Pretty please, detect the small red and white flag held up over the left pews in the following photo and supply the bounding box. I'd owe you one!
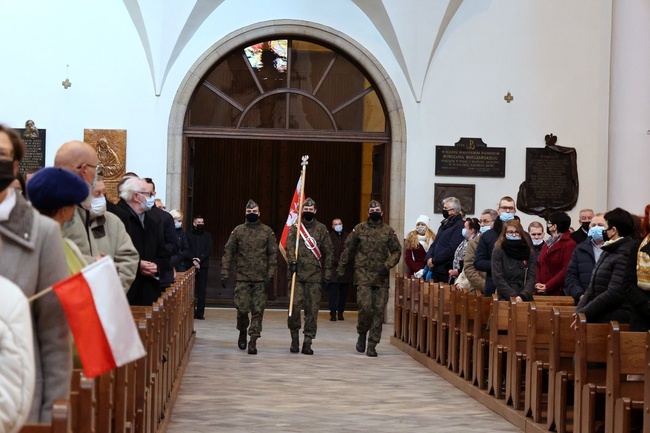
[52,257,146,378]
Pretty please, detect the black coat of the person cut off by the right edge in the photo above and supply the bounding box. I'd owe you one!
[621,241,650,332]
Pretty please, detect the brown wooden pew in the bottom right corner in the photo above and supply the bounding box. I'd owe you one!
[605,322,648,433]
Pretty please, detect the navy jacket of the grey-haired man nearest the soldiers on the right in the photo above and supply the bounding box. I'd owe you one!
[426,215,465,282]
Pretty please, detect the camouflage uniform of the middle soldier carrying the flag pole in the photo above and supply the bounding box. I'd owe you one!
[287,218,334,339]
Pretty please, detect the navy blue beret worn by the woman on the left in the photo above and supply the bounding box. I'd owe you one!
[27,167,90,209]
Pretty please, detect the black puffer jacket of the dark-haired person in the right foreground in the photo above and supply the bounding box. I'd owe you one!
[576,236,634,323]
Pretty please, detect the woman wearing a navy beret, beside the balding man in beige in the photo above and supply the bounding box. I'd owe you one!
[27,167,88,275]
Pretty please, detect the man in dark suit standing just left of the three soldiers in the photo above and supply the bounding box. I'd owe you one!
[185,215,212,320]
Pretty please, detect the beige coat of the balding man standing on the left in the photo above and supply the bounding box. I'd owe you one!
[63,207,140,293]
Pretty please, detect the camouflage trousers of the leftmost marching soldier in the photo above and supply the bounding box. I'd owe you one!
[235,281,266,337]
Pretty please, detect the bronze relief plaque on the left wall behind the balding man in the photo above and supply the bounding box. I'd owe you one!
[84,129,126,203]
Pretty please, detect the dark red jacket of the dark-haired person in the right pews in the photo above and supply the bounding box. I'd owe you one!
[537,231,576,296]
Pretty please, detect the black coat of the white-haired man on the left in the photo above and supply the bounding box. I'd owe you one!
[117,200,171,306]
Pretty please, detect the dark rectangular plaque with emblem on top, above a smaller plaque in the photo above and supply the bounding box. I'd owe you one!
[436,137,506,177]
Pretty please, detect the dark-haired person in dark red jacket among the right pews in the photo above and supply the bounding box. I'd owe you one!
[535,212,576,296]
